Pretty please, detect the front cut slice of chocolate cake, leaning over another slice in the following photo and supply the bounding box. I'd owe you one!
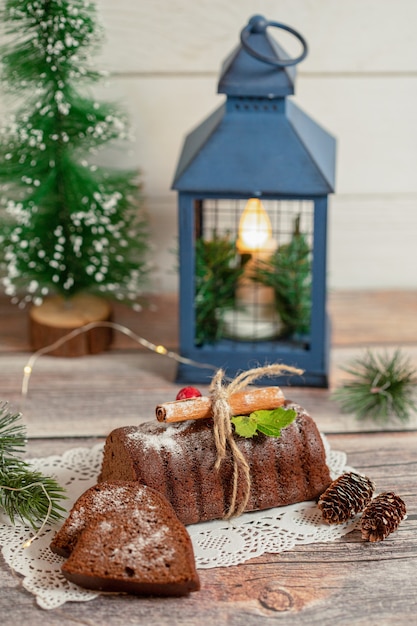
[62,502,200,596]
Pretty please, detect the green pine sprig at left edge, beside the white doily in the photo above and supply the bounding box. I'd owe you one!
[0,403,65,530]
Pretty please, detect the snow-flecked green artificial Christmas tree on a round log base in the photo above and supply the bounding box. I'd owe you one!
[0,0,147,352]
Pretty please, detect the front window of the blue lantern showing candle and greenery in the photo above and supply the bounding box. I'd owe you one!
[194,198,314,350]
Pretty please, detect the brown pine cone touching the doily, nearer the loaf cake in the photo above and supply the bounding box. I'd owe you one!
[318,472,375,524]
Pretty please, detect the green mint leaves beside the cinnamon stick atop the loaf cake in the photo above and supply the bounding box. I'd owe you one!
[231,407,297,437]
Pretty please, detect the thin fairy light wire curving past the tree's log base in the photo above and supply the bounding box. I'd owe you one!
[21,322,217,399]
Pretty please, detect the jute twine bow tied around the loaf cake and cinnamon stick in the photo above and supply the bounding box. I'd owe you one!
[210,364,303,519]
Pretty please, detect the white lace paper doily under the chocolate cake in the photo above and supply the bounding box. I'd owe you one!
[0,439,357,609]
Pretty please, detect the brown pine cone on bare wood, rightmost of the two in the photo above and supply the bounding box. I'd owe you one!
[361,491,407,541]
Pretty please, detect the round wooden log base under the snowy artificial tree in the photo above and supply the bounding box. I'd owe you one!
[29,294,113,357]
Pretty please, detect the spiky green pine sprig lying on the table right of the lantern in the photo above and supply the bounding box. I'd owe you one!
[332,350,417,422]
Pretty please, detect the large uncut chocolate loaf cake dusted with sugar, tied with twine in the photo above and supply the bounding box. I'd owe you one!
[99,401,331,524]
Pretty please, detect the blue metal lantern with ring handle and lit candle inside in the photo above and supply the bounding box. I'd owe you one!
[173,16,336,387]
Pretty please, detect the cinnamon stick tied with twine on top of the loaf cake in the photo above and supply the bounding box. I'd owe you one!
[156,387,285,422]
